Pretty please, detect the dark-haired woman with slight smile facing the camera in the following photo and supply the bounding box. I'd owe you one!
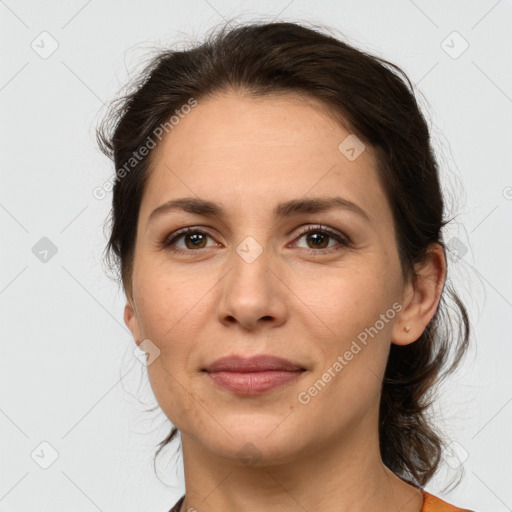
[98,19,476,512]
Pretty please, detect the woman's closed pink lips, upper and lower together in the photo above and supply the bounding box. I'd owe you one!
[204,355,306,396]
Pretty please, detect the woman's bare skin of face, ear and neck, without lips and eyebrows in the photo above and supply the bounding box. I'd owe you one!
[124,92,446,512]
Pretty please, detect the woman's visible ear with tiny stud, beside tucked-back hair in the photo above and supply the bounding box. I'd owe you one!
[391,243,446,345]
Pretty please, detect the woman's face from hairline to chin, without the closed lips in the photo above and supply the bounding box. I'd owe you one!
[125,94,410,462]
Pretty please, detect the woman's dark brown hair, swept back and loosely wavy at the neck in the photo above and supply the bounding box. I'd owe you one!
[97,22,469,486]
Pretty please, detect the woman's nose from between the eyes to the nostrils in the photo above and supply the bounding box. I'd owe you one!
[217,241,290,331]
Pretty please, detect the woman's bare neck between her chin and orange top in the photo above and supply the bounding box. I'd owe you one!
[181,414,423,512]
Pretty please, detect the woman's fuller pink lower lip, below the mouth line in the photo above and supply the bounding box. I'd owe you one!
[207,370,304,395]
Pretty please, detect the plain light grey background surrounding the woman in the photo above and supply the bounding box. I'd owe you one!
[0,0,512,512]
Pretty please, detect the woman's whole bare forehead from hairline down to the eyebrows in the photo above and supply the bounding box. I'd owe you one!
[141,94,387,228]
